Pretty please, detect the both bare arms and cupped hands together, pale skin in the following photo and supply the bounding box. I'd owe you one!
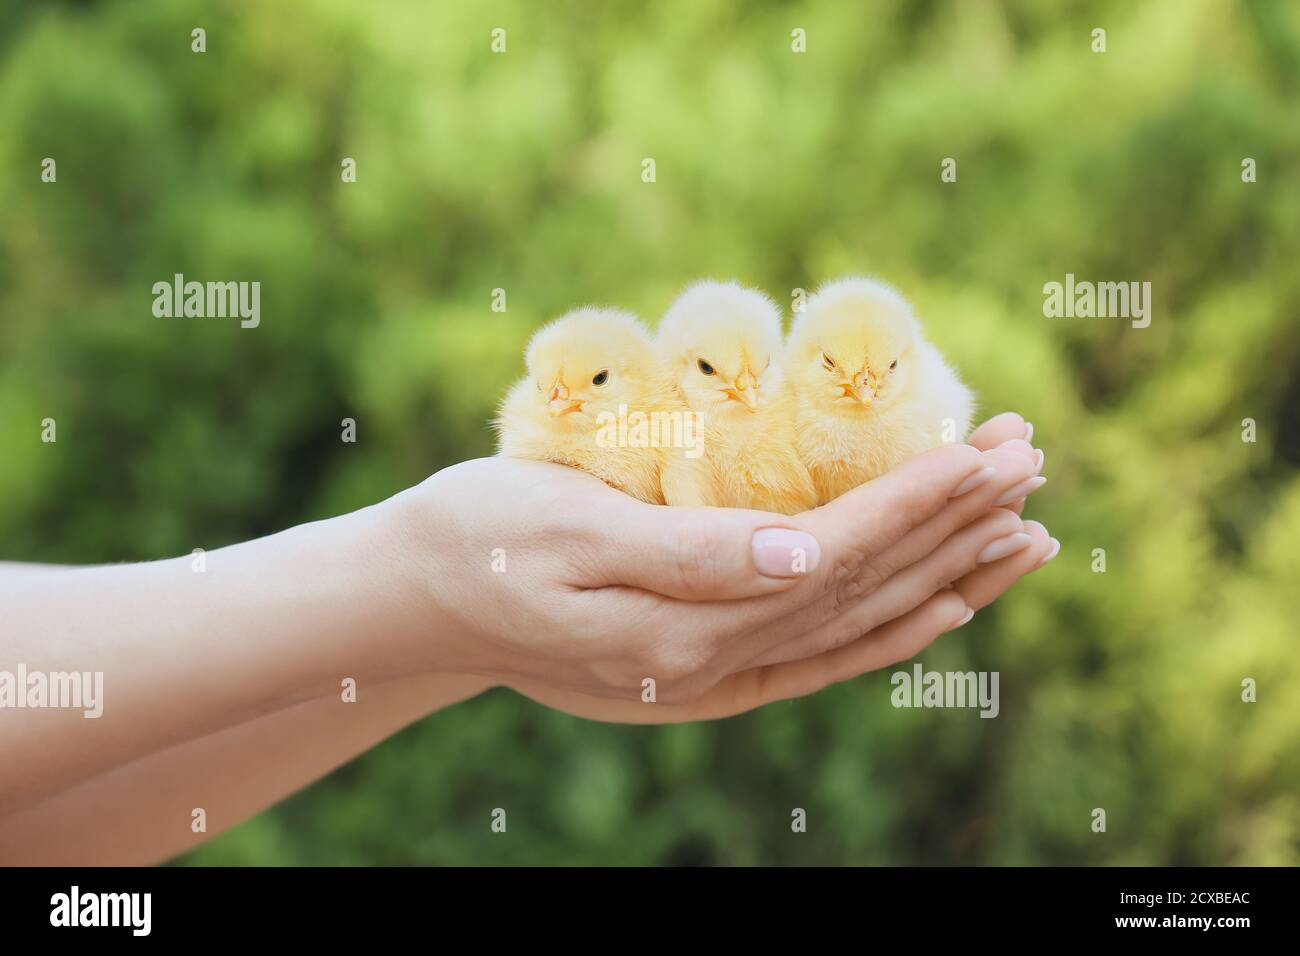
[0,414,1057,864]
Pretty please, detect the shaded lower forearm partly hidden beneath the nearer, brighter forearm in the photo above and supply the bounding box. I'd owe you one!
[0,674,489,866]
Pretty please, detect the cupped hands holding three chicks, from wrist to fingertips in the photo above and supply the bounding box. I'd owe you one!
[399,414,1054,722]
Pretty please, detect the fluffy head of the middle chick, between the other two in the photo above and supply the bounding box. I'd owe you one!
[658,281,781,415]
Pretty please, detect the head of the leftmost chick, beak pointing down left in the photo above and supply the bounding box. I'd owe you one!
[525,306,659,429]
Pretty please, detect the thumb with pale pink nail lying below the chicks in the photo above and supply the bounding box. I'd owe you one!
[593,499,822,601]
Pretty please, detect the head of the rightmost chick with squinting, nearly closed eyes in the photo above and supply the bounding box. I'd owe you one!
[787,278,919,414]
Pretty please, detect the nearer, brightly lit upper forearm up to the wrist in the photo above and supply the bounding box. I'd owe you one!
[0,502,438,813]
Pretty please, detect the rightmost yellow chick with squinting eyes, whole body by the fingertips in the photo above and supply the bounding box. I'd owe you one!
[785,278,974,505]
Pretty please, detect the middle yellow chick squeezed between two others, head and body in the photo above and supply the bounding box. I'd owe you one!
[657,282,816,515]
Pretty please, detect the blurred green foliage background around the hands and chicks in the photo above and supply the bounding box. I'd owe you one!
[0,0,1300,864]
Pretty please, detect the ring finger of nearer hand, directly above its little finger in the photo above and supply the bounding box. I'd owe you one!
[744,509,1034,666]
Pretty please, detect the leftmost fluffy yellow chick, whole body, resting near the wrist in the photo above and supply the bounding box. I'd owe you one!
[493,307,715,505]
